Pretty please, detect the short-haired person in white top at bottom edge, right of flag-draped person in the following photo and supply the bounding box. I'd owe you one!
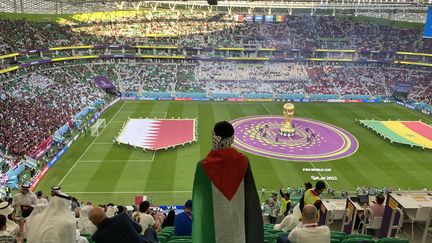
[277,204,330,243]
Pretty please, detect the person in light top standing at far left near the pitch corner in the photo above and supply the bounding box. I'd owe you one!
[12,185,37,217]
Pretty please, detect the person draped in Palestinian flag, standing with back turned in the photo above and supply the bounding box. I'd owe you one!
[192,121,264,243]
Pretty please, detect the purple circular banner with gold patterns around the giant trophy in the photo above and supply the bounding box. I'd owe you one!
[231,116,359,162]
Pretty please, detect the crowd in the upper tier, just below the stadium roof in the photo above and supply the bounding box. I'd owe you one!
[0,11,431,53]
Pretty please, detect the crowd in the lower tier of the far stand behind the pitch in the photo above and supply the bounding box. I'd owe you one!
[2,60,431,104]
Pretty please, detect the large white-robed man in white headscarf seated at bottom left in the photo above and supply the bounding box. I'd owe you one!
[27,192,77,243]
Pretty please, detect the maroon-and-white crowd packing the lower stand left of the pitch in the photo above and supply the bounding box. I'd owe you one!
[0,66,103,159]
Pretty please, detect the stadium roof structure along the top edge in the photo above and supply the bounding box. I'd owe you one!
[0,0,432,22]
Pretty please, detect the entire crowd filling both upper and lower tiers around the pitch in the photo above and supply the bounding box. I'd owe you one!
[0,11,432,173]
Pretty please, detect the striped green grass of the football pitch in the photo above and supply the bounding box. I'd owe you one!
[36,101,432,205]
